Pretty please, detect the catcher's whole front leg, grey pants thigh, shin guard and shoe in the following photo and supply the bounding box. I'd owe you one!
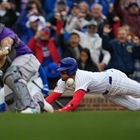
[4,54,40,112]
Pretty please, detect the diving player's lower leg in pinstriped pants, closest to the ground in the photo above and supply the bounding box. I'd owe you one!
[105,95,140,111]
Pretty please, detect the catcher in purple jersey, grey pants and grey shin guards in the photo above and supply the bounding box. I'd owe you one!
[0,23,44,113]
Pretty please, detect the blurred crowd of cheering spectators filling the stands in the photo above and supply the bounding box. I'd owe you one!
[0,0,140,89]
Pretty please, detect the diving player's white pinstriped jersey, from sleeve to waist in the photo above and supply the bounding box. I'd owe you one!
[54,69,114,94]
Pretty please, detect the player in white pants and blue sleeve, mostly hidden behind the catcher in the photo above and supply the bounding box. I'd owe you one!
[0,65,53,113]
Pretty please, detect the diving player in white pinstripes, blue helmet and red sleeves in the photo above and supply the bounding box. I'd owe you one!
[45,57,140,112]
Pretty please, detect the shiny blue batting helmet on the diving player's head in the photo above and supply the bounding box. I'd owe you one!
[57,57,78,76]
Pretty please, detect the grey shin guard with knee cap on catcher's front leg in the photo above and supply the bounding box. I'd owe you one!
[3,66,34,111]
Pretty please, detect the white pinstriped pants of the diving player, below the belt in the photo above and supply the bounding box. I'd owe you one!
[104,70,140,110]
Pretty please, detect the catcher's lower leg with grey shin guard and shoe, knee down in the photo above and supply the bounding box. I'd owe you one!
[4,66,40,113]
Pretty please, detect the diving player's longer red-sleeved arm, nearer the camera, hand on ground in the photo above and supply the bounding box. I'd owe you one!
[58,90,86,112]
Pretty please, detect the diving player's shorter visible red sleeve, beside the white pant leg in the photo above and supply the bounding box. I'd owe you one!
[45,92,62,104]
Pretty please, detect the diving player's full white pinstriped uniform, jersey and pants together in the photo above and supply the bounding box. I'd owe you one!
[54,69,140,110]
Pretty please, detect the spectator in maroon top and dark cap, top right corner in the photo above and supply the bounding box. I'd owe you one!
[114,0,140,38]
